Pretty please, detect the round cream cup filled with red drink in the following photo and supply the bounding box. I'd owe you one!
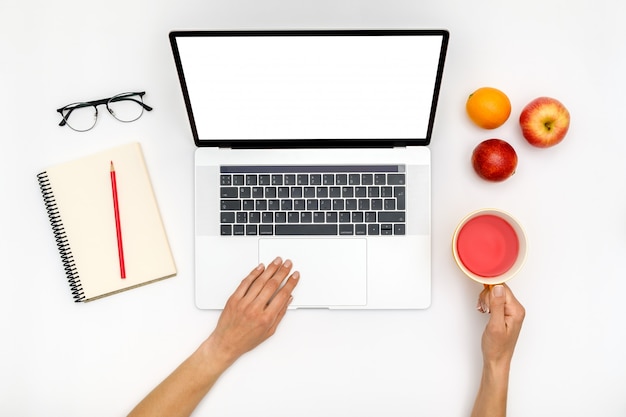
[452,208,526,285]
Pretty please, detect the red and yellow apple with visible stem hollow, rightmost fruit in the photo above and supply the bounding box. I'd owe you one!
[519,97,570,148]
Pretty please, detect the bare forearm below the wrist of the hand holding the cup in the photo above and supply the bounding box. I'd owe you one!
[472,364,509,417]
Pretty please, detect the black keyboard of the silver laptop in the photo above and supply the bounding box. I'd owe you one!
[220,165,406,236]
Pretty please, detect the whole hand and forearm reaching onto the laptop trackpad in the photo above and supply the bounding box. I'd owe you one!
[129,257,300,417]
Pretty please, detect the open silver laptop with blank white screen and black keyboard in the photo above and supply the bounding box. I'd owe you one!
[169,30,449,310]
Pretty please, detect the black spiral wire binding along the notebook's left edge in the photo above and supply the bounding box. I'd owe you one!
[37,171,85,303]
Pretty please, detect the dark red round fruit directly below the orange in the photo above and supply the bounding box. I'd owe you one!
[472,139,517,181]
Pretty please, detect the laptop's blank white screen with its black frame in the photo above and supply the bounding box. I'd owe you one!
[169,30,449,148]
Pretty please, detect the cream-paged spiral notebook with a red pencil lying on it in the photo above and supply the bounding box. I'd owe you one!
[37,143,176,302]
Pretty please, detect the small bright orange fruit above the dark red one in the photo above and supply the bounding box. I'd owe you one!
[465,87,511,129]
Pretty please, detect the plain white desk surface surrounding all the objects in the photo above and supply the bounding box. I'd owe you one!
[0,0,626,417]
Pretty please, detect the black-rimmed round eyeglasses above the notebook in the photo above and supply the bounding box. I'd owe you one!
[57,91,152,132]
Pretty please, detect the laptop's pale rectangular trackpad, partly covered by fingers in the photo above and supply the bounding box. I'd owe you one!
[259,238,367,307]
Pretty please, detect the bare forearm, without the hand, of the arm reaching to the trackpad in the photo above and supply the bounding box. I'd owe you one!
[129,341,232,417]
